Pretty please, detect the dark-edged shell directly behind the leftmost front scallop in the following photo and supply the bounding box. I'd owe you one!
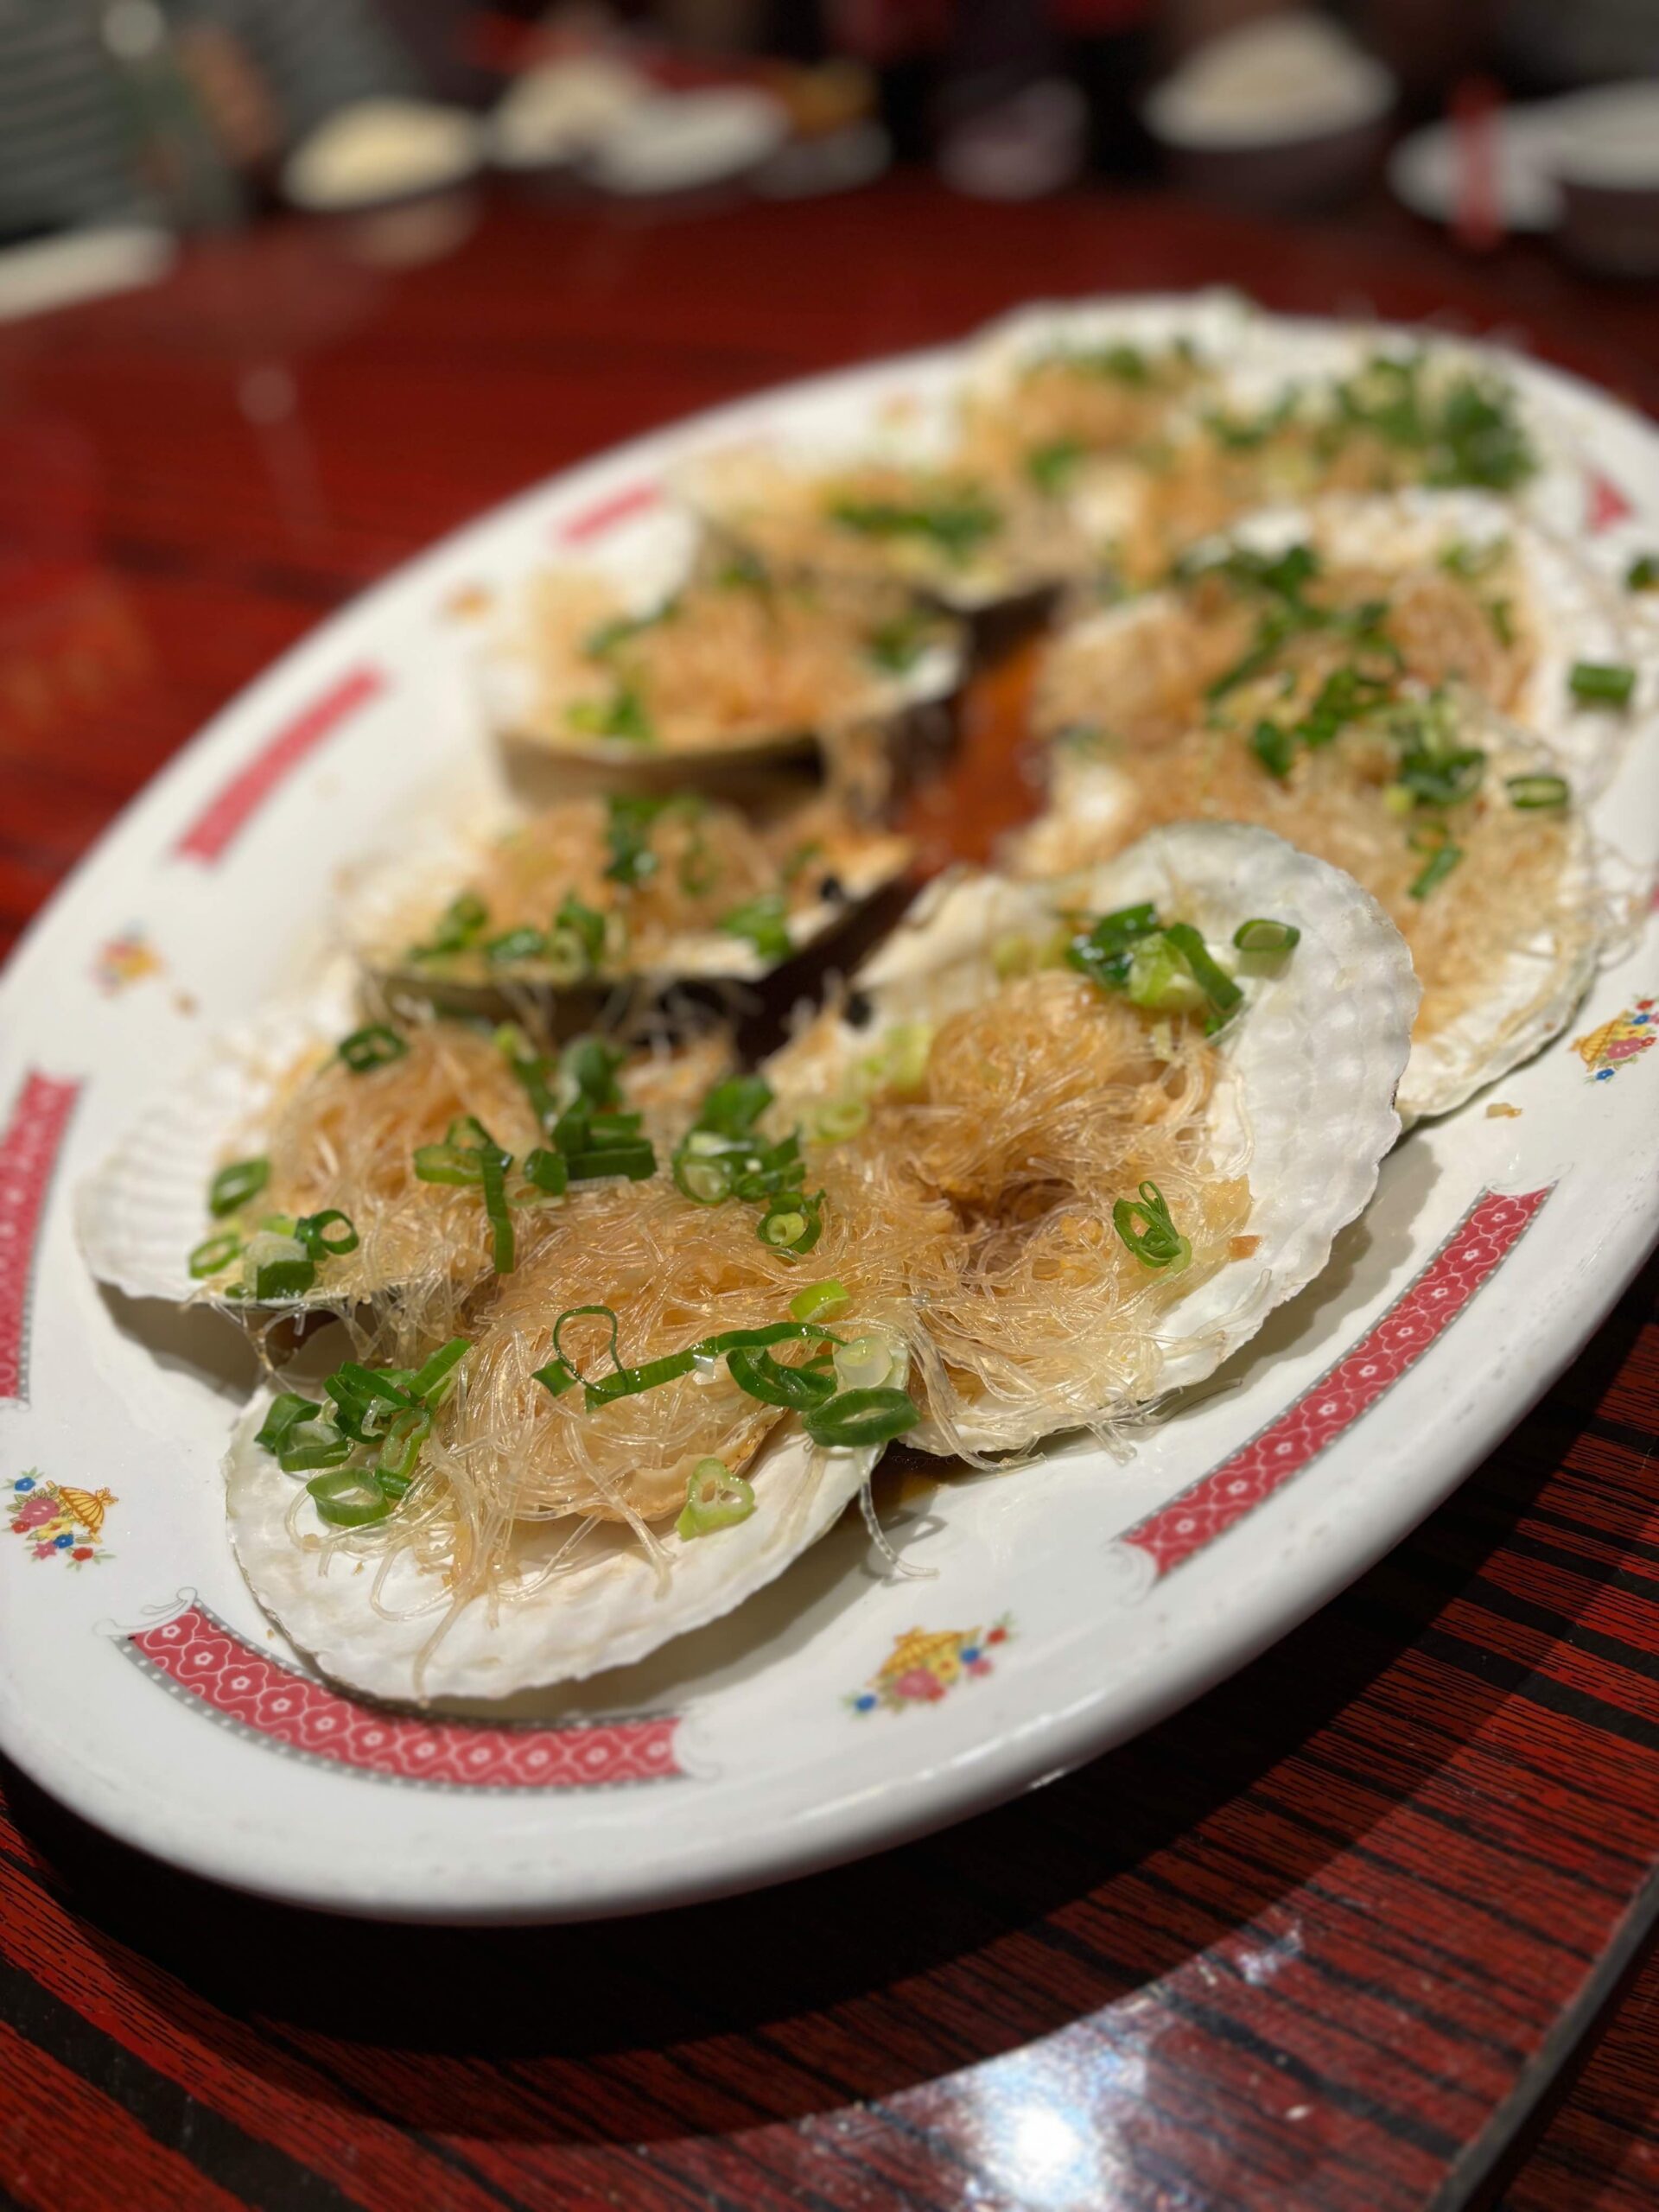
[343,817,913,1004]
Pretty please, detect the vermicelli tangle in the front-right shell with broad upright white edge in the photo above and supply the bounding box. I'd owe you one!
[798,971,1249,1445]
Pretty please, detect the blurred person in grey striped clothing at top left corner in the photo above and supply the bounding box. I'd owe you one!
[0,0,416,238]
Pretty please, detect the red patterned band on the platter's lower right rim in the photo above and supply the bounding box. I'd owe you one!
[1119,1184,1555,1575]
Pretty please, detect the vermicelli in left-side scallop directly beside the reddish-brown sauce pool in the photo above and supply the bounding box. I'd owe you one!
[524,557,947,752]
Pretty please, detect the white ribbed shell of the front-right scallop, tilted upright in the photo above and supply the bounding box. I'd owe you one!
[767,823,1418,1453]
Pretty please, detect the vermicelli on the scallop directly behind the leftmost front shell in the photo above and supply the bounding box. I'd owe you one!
[389,791,909,982]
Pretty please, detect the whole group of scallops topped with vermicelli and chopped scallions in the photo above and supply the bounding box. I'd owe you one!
[78,296,1659,1701]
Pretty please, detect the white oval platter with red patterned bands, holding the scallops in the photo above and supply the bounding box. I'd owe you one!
[0,301,1659,1920]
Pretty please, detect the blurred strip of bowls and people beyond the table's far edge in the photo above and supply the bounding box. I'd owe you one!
[0,0,1659,249]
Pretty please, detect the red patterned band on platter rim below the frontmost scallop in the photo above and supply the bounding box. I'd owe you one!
[122,1599,686,1789]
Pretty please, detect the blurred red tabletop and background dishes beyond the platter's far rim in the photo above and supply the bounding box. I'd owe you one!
[0,0,1659,951]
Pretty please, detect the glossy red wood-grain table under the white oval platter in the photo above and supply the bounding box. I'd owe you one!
[0,179,1659,2212]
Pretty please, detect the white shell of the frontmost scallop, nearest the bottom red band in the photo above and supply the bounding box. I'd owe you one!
[226,1391,880,1701]
